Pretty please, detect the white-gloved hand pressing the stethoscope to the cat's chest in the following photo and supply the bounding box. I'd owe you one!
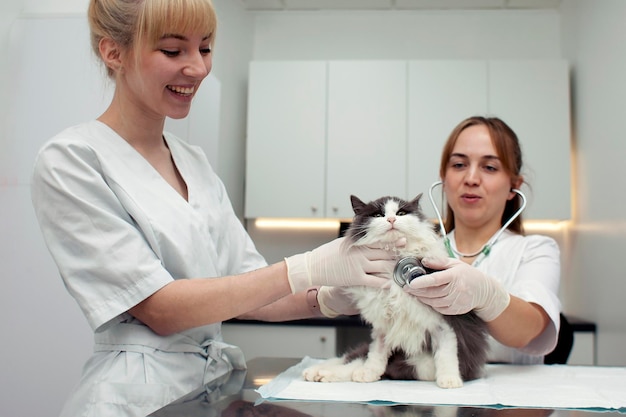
[404,258,511,321]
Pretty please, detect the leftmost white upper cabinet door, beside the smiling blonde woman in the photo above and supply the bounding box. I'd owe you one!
[245,61,326,218]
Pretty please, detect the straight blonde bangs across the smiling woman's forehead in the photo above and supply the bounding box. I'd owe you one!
[137,0,217,45]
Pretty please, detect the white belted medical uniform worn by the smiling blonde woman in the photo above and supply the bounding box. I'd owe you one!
[32,121,266,417]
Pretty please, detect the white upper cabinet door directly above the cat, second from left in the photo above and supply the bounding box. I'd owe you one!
[326,61,407,218]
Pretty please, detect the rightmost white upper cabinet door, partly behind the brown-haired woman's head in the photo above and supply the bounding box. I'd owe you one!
[489,60,571,220]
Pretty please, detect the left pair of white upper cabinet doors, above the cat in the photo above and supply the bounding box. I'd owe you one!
[245,61,406,218]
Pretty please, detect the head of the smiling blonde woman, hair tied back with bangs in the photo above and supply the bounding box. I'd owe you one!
[88,0,217,123]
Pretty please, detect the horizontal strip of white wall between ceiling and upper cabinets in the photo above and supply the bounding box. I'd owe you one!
[254,10,560,60]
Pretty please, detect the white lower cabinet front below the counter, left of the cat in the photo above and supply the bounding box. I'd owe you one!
[222,323,337,360]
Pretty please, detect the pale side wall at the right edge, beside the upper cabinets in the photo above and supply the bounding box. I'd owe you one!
[562,0,626,365]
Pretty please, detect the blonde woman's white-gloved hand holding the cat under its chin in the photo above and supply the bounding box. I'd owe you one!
[285,238,399,294]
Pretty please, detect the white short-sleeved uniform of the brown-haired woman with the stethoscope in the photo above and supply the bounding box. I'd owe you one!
[448,230,561,364]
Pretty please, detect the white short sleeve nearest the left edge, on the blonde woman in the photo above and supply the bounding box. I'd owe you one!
[31,136,172,330]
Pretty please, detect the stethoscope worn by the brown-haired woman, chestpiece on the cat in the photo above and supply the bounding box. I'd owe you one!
[393,180,526,287]
